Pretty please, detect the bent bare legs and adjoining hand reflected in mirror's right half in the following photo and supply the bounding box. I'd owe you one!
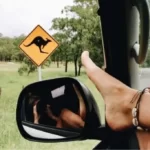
[43,84,86,128]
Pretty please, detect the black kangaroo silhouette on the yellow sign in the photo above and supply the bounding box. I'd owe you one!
[24,36,51,54]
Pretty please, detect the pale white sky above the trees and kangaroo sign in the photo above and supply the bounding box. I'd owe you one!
[0,0,73,37]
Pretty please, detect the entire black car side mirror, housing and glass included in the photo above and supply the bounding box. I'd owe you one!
[16,77,106,142]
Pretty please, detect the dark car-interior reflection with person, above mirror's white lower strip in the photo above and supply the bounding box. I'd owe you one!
[25,84,86,129]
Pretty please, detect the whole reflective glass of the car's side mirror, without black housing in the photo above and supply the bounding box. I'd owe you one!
[21,81,86,139]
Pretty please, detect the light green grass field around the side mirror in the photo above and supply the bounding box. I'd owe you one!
[0,63,104,150]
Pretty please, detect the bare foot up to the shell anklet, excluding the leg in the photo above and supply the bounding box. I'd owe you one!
[81,51,137,131]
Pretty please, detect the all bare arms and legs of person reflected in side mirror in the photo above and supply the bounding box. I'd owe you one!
[33,85,86,128]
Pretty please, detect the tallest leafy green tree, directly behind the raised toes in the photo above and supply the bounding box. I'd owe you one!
[51,0,103,76]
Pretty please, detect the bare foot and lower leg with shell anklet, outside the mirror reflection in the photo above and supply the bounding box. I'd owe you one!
[81,51,150,150]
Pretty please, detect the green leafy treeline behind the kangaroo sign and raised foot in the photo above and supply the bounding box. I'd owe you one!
[0,0,150,76]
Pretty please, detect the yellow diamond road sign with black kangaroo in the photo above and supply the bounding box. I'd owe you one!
[19,25,58,66]
